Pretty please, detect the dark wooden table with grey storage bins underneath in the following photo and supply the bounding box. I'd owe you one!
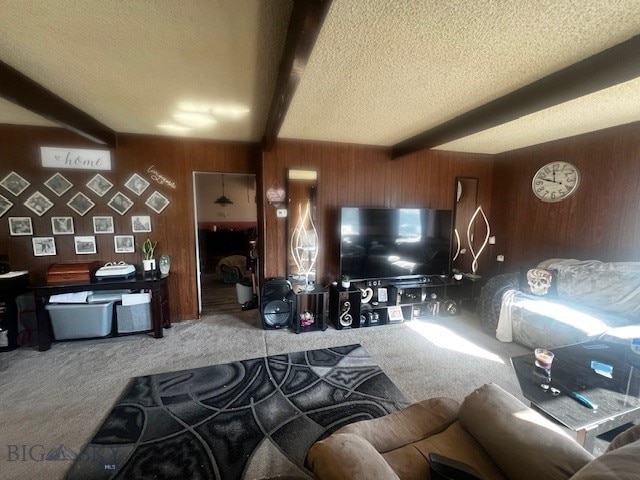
[32,274,171,352]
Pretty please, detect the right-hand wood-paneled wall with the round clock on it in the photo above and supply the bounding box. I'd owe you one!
[492,123,640,271]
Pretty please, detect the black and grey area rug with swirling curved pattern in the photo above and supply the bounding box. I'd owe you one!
[67,344,409,479]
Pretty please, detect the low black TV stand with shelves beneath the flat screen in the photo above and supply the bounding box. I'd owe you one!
[329,275,462,330]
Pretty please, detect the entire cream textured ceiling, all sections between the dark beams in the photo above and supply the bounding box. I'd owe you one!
[0,0,640,153]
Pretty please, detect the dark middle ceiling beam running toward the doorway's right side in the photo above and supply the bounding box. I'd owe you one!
[262,0,331,151]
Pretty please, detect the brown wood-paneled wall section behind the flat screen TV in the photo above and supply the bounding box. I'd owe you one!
[262,140,493,284]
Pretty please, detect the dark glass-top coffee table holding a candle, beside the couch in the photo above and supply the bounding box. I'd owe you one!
[511,341,640,452]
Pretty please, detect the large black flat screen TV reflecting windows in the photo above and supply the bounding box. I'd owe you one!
[340,207,453,280]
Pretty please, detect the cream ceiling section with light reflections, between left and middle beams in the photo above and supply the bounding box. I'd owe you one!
[0,0,291,140]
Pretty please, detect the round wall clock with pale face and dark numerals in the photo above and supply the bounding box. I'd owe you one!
[531,161,580,202]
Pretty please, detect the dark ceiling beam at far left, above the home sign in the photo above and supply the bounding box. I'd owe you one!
[0,61,116,147]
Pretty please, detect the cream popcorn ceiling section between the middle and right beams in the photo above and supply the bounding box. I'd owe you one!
[280,0,640,151]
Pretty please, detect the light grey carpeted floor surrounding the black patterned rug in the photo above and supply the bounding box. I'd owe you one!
[0,310,528,479]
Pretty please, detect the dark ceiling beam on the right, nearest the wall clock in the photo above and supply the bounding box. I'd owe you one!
[392,35,640,159]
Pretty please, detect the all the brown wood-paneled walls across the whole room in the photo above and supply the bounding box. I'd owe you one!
[16,118,640,321]
